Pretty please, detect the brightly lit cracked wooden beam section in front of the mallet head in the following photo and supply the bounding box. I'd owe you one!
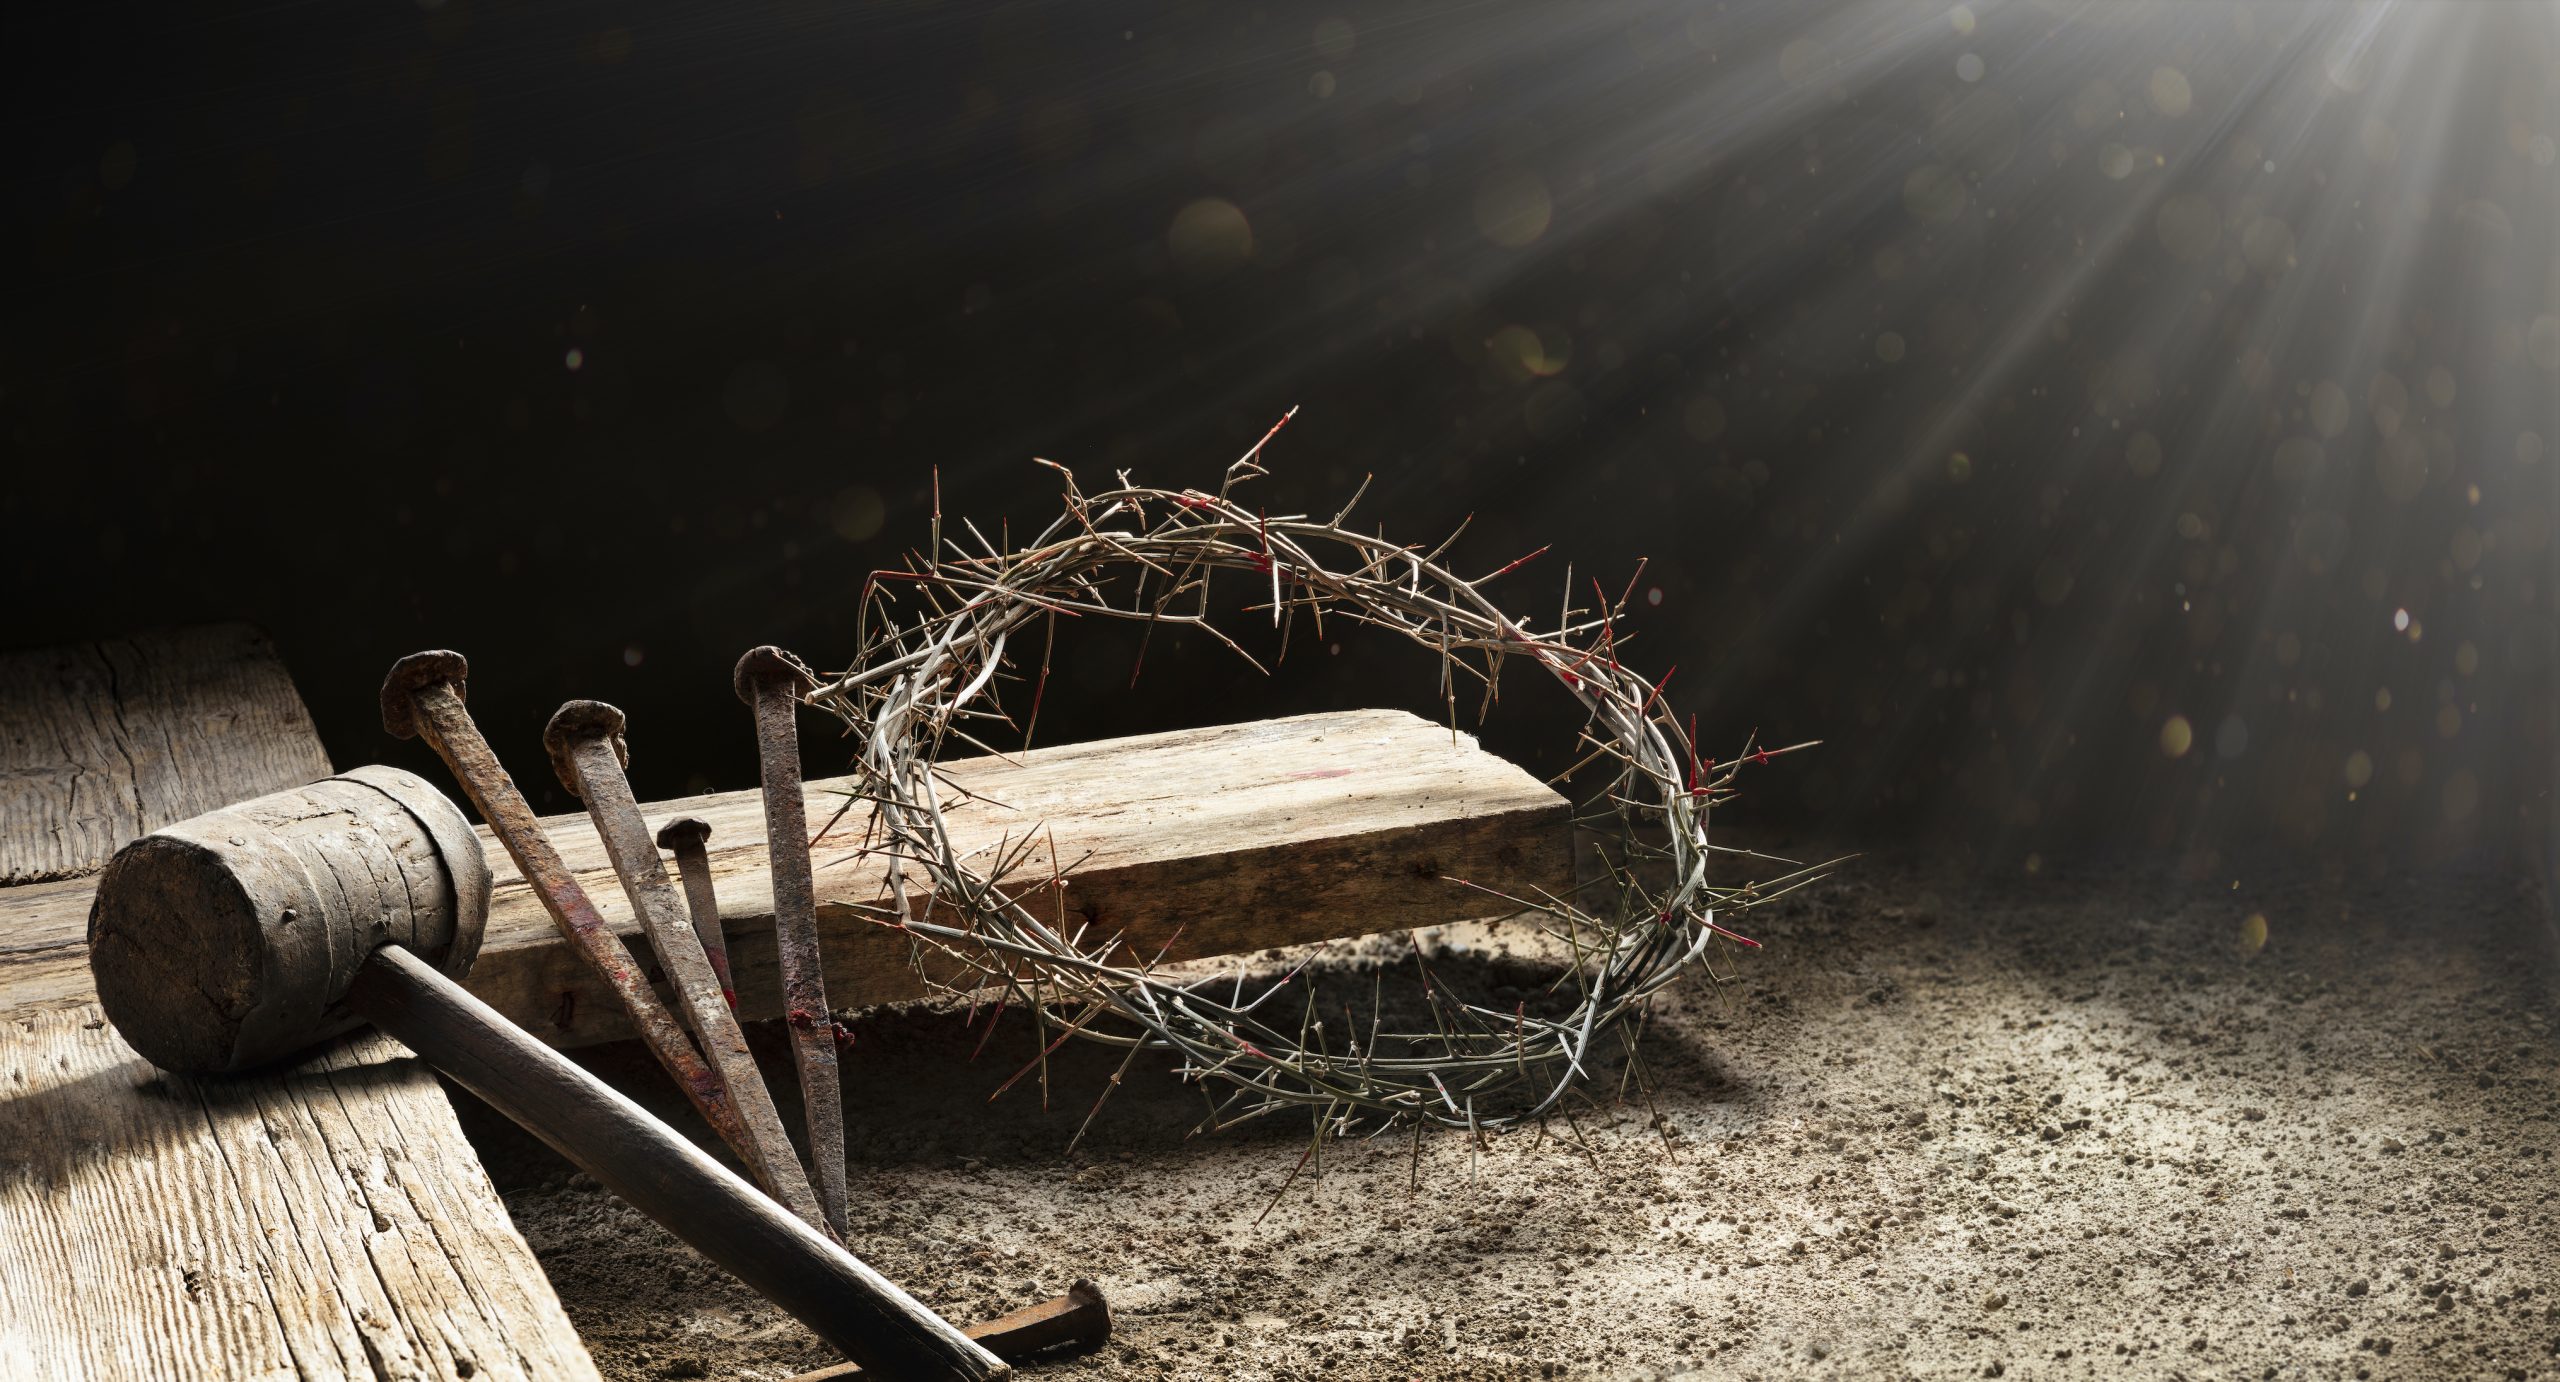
[0,1008,596,1382]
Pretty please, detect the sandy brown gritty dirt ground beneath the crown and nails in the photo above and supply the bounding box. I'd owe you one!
[463,860,2560,1379]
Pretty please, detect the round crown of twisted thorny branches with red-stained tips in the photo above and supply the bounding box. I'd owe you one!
[806,435,1815,1139]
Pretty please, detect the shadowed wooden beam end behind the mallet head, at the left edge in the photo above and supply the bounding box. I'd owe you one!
[0,624,330,886]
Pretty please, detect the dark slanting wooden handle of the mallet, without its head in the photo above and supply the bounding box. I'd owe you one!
[346,944,1009,1379]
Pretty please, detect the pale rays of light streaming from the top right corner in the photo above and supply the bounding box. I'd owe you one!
[1034,3,2552,873]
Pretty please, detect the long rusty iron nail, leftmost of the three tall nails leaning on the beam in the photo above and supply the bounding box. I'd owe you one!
[381,650,745,1187]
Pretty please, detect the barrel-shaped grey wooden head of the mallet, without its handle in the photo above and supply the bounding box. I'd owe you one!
[90,768,489,1072]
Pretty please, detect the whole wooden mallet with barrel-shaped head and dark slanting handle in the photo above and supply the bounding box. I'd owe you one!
[90,768,1006,1379]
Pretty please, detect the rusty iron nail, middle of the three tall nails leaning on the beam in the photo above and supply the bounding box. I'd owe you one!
[543,701,827,1234]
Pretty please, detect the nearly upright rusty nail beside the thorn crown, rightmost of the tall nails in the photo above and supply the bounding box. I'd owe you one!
[735,645,845,1231]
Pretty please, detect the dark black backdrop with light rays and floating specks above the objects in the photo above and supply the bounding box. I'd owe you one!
[20,0,2560,875]
